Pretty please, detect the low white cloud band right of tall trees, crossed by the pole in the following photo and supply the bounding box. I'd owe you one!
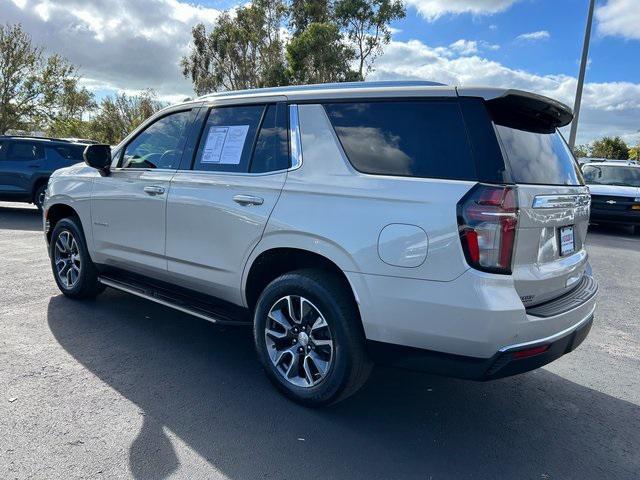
[371,40,640,144]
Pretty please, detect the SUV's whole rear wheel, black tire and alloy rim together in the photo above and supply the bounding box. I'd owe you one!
[254,270,371,407]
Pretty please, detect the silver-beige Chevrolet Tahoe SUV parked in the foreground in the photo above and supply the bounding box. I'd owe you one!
[44,82,597,405]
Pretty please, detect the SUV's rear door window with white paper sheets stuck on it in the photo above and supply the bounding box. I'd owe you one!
[194,105,265,173]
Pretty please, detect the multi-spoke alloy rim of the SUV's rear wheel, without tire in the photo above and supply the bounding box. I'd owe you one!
[264,295,334,388]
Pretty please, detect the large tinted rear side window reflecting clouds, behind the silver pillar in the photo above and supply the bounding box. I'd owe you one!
[325,100,477,180]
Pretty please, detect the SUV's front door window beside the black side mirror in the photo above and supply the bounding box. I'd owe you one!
[121,110,191,169]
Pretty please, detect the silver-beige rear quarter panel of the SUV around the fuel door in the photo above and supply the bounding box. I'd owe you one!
[254,105,473,282]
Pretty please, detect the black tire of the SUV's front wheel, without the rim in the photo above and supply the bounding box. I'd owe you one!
[49,217,104,299]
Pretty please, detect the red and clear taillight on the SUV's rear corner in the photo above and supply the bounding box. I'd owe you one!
[458,184,518,274]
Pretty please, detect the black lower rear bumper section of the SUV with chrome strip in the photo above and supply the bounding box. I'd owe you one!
[368,313,593,381]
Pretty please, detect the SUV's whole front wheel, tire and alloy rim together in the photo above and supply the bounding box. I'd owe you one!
[49,217,104,298]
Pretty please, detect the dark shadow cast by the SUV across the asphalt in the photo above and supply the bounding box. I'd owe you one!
[48,290,640,480]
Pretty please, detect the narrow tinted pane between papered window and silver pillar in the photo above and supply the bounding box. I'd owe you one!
[250,105,289,173]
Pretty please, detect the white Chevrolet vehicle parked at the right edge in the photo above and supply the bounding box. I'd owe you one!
[582,160,640,233]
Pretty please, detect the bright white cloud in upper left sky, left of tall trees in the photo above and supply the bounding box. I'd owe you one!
[0,0,220,99]
